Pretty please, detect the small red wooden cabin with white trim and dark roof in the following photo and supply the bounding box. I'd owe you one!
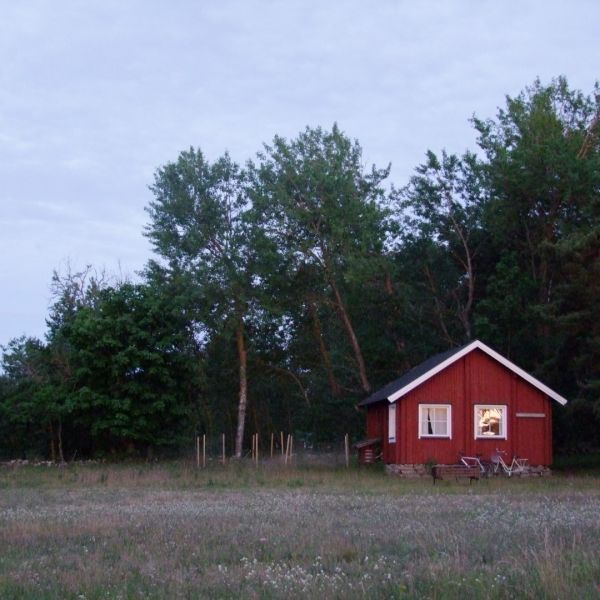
[359,340,567,466]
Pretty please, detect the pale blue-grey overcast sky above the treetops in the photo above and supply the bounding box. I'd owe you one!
[0,0,600,344]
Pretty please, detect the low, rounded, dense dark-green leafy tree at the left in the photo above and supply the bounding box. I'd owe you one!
[64,283,199,452]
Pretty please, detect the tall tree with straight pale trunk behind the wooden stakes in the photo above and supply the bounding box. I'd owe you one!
[146,148,253,457]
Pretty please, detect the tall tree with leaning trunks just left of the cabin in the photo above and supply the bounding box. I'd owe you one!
[250,125,389,393]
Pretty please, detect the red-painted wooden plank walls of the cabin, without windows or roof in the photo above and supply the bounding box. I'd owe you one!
[367,350,552,465]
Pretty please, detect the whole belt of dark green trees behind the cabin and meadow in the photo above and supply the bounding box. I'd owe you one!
[0,78,600,460]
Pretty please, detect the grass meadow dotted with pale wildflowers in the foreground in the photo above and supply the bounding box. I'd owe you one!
[0,462,600,599]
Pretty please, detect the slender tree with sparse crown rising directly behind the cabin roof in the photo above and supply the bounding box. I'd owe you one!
[397,151,486,344]
